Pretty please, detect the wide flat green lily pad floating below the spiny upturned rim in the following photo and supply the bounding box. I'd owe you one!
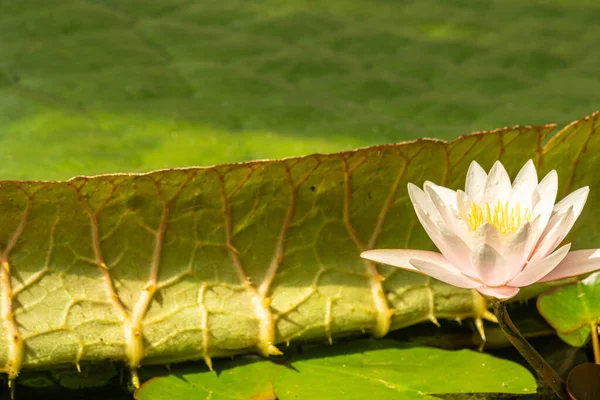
[136,340,536,400]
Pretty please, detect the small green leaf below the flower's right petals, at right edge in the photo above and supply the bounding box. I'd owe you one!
[537,273,600,346]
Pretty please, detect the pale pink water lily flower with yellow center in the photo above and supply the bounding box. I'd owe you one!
[361,160,600,300]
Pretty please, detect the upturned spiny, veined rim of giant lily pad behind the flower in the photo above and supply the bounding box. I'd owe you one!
[0,113,600,388]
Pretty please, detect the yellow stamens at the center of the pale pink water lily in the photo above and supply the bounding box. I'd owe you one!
[467,200,531,235]
